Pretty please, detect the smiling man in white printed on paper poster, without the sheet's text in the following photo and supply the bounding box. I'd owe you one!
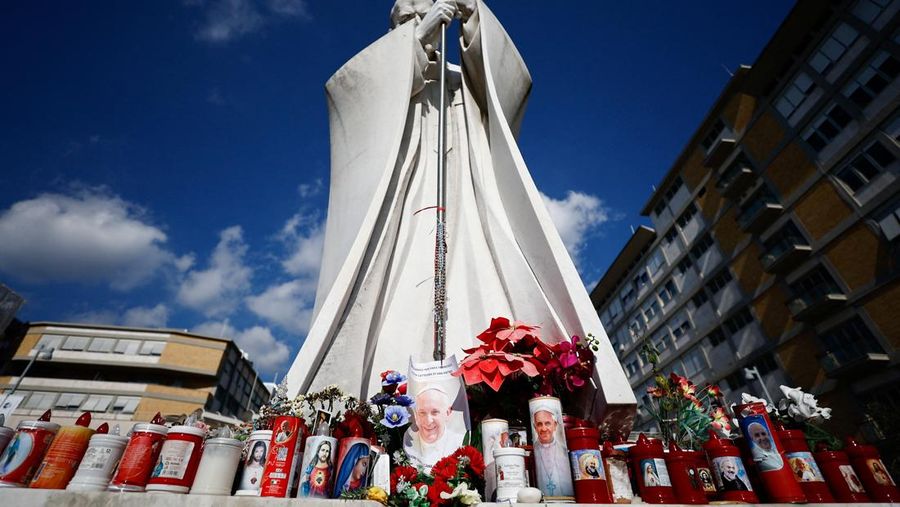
[403,385,465,467]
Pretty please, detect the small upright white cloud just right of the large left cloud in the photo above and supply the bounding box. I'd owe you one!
[177,226,253,317]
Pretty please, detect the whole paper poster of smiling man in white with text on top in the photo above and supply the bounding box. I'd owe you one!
[403,357,469,467]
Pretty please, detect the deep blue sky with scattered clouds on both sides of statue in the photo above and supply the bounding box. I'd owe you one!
[0,0,792,377]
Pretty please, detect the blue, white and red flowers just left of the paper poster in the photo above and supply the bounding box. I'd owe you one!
[369,370,413,455]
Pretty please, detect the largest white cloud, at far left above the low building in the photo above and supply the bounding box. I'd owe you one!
[0,188,176,290]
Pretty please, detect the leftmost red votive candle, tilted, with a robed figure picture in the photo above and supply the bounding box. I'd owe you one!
[0,410,59,488]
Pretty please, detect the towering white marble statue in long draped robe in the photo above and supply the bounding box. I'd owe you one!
[288,0,635,428]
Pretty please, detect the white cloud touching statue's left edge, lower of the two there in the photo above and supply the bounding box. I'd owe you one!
[246,280,316,335]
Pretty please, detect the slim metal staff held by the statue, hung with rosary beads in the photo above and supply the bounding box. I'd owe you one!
[434,24,447,361]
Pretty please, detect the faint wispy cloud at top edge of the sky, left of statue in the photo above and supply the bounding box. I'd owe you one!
[186,0,309,43]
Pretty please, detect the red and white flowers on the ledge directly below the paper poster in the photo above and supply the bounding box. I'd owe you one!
[388,446,484,507]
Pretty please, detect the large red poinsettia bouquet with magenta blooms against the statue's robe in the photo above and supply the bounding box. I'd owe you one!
[453,317,598,423]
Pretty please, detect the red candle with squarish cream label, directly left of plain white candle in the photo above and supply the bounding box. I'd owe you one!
[146,426,206,494]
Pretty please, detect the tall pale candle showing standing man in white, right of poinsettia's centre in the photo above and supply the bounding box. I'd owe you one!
[528,397,575,498]
